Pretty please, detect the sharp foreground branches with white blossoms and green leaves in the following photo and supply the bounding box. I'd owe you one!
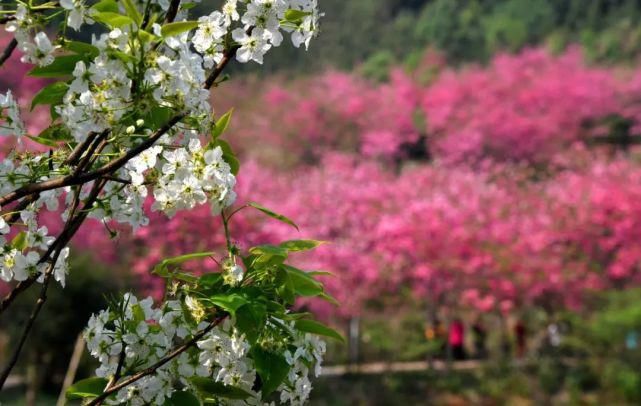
[0,0,337,404]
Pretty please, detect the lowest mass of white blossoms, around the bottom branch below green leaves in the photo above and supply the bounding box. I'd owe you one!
[84,294,325,405]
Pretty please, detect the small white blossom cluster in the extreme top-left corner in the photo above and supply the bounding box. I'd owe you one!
[6,3,56,66]
